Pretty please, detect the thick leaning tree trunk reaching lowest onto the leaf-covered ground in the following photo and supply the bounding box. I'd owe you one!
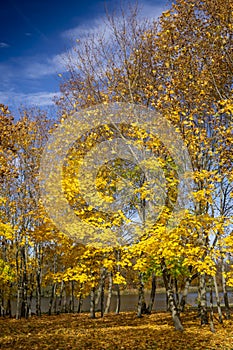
[161,259,184,331]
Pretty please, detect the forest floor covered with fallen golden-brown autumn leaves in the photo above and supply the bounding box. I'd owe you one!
[0,311,233,350]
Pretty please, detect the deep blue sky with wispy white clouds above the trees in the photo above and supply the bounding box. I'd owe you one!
[0,0,167,113]
